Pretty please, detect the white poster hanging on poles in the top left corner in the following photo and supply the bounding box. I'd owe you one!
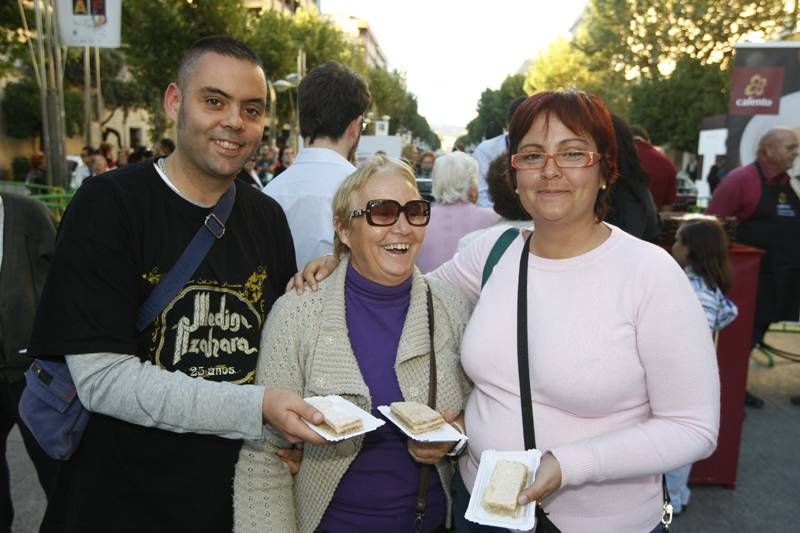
[56,0,122,48]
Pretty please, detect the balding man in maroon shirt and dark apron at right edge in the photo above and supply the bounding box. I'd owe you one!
[707,128,800,408]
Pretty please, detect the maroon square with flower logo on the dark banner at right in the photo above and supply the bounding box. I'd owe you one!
[728,67,783,115]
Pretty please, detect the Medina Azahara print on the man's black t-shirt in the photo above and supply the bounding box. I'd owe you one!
[148,267,267,383]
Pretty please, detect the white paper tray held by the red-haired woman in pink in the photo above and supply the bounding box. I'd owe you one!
[464,450,542,531]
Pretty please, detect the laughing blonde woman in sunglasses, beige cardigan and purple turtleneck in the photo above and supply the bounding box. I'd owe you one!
[234,156,470,533]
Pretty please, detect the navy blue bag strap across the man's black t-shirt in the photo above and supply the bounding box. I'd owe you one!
[136,182,236,331]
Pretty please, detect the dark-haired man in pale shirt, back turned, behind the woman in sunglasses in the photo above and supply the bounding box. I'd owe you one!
[264,61,370,268]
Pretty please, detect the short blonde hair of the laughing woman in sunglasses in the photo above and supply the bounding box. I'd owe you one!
[333,155,418,259]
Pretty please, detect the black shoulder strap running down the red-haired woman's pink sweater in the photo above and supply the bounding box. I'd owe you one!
[517,233,672,533]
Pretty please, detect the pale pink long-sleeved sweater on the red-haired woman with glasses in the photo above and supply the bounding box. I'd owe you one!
[433,226,719,533]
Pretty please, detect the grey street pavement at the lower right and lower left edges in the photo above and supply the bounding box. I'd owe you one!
[8,326,800,533]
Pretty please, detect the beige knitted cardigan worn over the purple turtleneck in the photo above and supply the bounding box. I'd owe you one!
[234,260,471,533]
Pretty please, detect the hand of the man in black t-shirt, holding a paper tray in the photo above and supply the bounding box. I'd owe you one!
[261,389,326,445]
